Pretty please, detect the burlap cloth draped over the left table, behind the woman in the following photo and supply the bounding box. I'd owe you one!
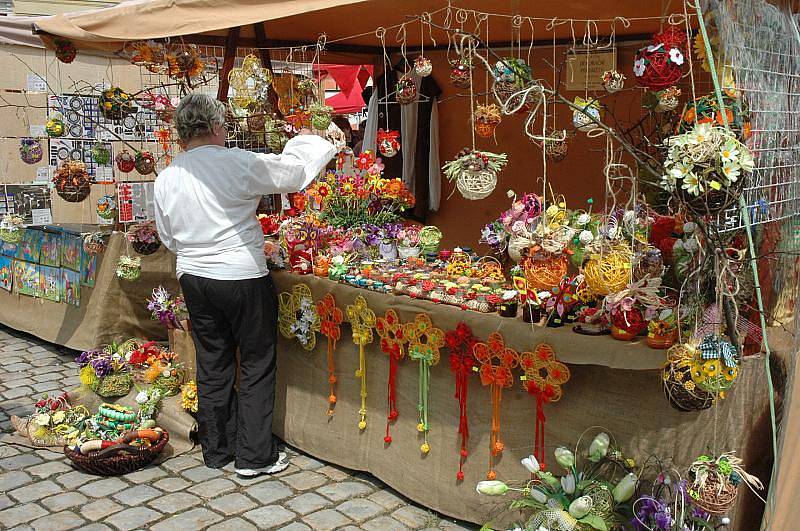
[0,232,178,350]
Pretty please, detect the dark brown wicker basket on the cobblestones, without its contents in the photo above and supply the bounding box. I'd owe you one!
[64,431,169,476]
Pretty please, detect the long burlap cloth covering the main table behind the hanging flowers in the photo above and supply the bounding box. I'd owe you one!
[174,272,770,530]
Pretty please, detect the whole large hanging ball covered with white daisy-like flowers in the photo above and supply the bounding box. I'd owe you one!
[661,124,755,216]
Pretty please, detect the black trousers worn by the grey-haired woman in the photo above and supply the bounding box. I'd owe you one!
[180,274,278,468]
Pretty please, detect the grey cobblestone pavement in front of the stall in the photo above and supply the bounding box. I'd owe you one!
[0,325,474,531]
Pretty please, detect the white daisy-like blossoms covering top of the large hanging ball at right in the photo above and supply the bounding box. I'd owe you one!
[661,124,755,197]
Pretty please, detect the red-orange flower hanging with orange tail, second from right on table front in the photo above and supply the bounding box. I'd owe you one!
[472,332,519,480]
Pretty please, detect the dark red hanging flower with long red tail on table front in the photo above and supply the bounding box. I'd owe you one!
[444,322,477,481]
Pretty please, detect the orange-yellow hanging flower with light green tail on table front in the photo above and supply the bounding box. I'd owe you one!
[403,313,444,454]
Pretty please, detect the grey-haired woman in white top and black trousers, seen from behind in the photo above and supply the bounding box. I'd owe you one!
[155,94,335,477]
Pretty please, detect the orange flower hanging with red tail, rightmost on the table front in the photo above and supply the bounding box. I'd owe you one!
[520,343,570,468]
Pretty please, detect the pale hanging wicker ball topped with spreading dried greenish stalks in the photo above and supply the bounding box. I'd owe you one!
[442,148,508,201]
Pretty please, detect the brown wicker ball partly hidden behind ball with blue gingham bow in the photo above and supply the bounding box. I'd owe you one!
[661,344,714,411]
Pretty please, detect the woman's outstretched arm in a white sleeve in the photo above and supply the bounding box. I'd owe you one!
[249,135,336,195]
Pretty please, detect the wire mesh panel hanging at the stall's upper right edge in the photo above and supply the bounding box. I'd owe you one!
[710,0,800,231]
